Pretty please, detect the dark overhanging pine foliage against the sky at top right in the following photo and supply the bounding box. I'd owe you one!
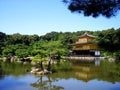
[63,0,120,17]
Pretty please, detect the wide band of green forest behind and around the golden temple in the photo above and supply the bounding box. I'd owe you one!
[0,28,120,58]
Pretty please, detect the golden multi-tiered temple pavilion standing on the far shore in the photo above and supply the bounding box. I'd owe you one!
[71,33,100,56]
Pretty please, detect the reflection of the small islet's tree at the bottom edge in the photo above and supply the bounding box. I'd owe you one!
[30,76,64,90]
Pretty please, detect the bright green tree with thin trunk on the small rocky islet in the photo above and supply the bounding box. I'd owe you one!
[30,40,68,70]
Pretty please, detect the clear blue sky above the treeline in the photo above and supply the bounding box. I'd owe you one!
[0,0,120,36]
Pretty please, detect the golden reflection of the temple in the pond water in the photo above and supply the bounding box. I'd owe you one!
[74,65,100,82]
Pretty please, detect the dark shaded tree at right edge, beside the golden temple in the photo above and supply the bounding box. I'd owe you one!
[97,28,120,56]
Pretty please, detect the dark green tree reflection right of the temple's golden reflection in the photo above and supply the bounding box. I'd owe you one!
[97,61,120,83]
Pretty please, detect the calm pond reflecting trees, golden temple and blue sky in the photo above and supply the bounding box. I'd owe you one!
[0,61,120,90]
